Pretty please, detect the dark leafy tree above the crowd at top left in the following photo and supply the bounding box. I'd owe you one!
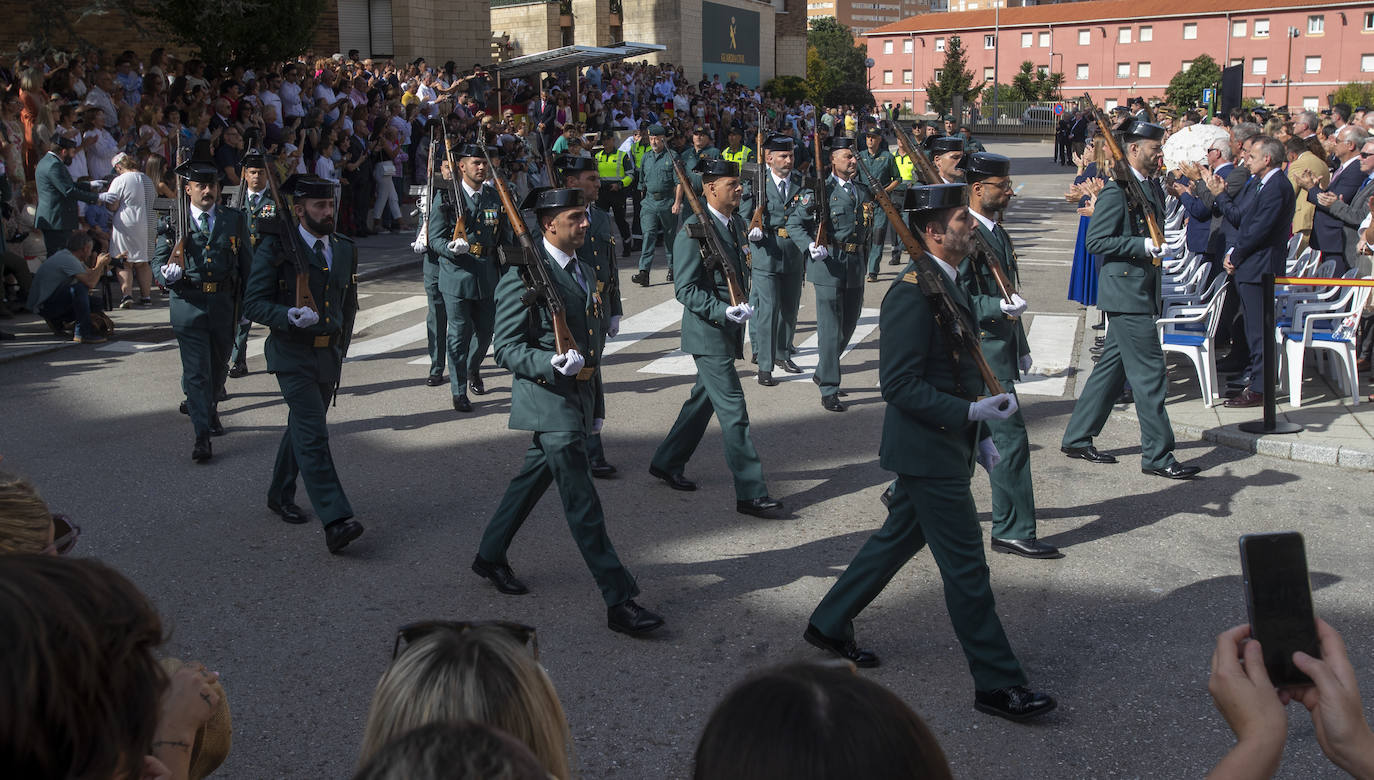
[143,0,324,69]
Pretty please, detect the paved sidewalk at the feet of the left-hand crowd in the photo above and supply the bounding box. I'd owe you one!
[0,231,420,364]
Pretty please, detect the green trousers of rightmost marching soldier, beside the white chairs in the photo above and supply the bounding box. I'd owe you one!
[1063,314,1175,468]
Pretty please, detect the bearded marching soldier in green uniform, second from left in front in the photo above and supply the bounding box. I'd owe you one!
[243,176,363,553]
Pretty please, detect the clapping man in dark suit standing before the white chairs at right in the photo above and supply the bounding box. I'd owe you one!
[1208,136,1301,408]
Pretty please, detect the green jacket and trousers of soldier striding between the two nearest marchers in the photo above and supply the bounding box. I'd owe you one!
[650,209,768,501]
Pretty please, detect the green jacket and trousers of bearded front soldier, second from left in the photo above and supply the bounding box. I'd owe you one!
[243,220,357,526]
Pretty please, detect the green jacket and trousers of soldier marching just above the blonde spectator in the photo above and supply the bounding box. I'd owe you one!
[478,240,639,606]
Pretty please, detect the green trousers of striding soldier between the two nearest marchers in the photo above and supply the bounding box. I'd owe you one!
[650,354,768,501]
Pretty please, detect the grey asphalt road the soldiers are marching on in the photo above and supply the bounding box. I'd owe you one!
[0,144,1374,779]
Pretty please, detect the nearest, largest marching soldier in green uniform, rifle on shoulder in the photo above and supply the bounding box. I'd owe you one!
[802,184,1055,721]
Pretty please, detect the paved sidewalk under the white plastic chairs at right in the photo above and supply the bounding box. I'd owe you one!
[1074,309,1374,471]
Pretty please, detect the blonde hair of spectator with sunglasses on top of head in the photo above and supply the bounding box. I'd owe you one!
[359,628,570,780]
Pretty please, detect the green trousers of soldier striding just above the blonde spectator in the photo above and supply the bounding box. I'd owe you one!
[477,431,639,607]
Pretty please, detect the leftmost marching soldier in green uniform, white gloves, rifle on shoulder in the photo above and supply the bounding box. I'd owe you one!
[153,162,253,463]
